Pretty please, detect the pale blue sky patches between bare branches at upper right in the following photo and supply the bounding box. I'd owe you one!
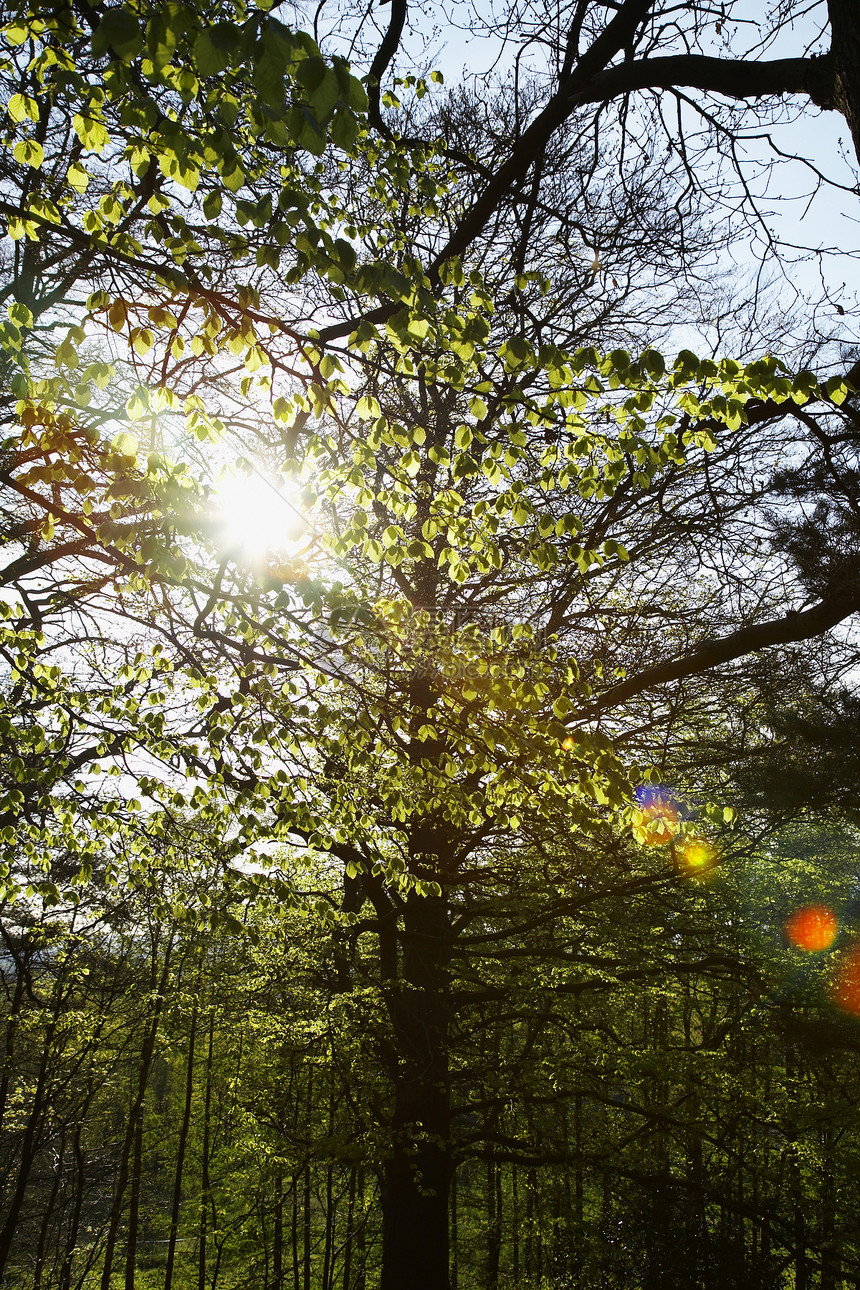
[306,0,860,365]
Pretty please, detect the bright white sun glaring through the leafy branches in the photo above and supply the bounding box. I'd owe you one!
[213,471,311,565]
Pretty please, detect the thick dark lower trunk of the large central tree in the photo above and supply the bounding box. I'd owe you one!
[380,891,454,1290]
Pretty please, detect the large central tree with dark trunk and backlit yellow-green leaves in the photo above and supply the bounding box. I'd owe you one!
[1,0,857,1290]
